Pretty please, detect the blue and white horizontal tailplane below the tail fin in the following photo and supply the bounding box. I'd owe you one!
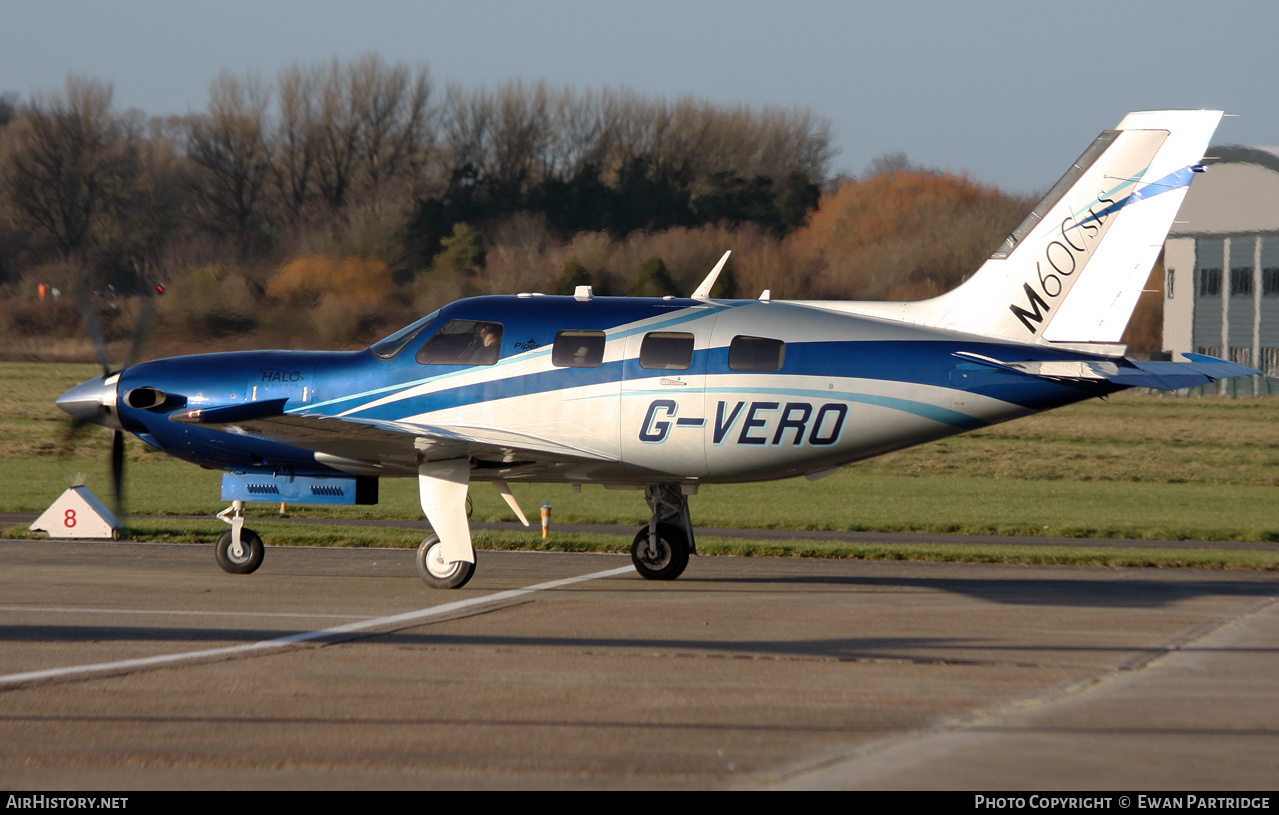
[954,351,1261,390]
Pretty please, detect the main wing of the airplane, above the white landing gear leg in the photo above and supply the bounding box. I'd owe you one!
[171,399,614,473]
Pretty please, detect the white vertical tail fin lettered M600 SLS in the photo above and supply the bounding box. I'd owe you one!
[828,110,1221,343]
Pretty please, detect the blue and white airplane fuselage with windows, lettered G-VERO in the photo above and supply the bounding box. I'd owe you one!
[116,296,1118,484]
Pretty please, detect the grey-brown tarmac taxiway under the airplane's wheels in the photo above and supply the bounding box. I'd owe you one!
[0,540,1279,791]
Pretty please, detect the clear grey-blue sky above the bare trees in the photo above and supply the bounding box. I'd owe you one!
[0,0,1279,194]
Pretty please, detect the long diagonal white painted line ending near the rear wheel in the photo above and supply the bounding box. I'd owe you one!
[0,564,634,687]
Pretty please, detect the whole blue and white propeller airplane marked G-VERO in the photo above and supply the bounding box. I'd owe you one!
[58,110,1257,587]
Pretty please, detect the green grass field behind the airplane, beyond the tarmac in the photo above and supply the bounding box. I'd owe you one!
[9,363,1279,562]
